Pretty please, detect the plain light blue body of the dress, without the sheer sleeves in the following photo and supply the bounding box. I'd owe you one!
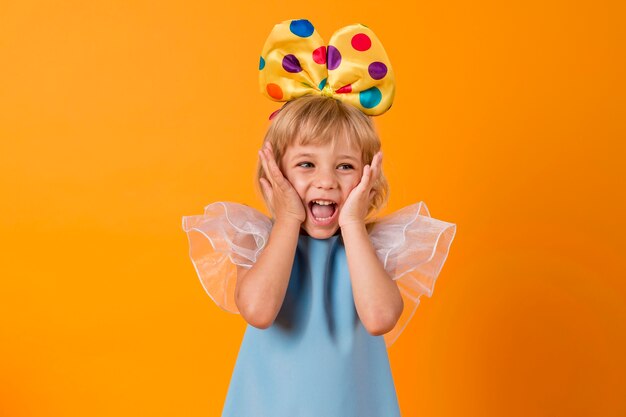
[222,235,400,417]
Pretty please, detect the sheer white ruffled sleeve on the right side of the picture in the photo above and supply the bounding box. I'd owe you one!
[370,201,456,347]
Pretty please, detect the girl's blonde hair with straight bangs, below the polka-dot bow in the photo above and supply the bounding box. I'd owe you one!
[255,95,389,222]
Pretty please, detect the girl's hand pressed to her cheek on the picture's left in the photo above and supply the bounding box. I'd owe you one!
[259,142,306,224]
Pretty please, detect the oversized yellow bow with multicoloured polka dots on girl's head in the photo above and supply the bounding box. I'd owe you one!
[259,19,395,118]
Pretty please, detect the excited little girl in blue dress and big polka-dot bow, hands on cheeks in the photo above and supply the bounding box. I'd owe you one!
[183,19,456,417]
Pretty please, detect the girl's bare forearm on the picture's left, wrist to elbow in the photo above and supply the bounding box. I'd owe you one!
[235,220,300,328]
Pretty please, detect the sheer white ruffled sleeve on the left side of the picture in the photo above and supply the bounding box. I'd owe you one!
[178,202,272,313]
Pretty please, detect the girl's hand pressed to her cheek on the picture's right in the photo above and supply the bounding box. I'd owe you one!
[339,151,383,227]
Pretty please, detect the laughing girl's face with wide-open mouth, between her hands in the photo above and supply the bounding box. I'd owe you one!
[280,140,364,239]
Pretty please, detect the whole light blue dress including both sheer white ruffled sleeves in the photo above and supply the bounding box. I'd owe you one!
[183,202,456,417]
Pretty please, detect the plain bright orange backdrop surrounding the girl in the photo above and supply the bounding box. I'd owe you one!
[0,0,626,417]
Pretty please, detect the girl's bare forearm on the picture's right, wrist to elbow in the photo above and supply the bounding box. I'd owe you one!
[341,223,404,335]
